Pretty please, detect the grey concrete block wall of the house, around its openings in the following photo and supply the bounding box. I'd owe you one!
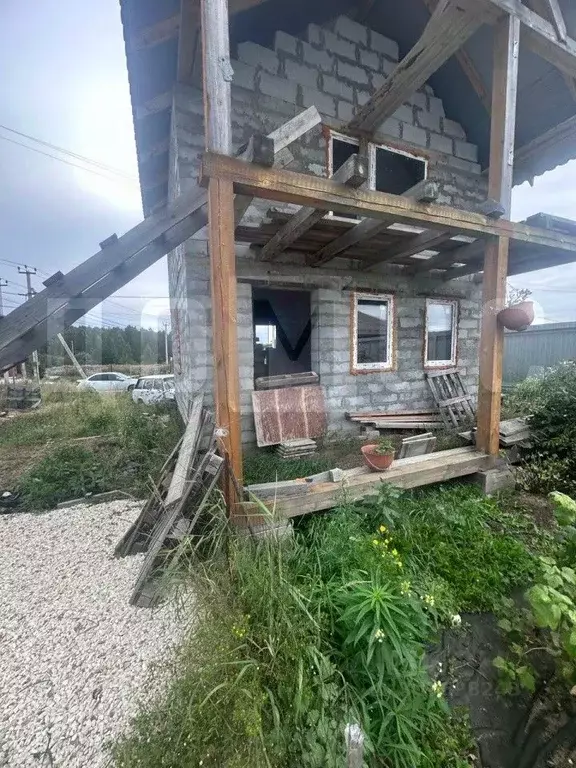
[169,12,486,443]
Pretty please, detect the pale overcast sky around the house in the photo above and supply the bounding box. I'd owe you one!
[0,0,576,325]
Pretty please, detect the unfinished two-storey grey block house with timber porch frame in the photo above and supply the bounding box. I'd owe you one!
[115,0,576,498]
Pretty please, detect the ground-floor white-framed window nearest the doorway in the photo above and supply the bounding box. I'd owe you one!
[351,293,394,373]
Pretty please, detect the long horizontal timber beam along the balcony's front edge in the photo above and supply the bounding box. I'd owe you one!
[202,153,576,253]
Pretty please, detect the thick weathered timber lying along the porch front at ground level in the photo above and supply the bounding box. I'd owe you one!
[274,447,492,517]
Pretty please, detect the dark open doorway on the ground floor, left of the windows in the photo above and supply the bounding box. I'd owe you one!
[252,288,312,379]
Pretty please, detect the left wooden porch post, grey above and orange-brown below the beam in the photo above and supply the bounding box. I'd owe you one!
[201,0,242,496]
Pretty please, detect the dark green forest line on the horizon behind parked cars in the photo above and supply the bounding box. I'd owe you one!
[40,325,172,368]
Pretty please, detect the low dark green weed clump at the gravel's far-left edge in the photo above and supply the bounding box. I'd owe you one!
[19,446,110,509]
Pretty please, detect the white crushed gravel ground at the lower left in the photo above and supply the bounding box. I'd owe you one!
[0,501,183,768]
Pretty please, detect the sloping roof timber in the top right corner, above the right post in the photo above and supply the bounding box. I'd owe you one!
[484,0,576,77]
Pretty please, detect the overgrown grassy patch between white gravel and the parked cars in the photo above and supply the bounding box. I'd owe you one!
[9,390,181,510]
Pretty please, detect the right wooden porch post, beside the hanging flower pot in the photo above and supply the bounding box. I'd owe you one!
[477,15,520,456]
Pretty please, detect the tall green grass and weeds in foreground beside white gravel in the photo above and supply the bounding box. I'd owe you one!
[112,486,537,768]
